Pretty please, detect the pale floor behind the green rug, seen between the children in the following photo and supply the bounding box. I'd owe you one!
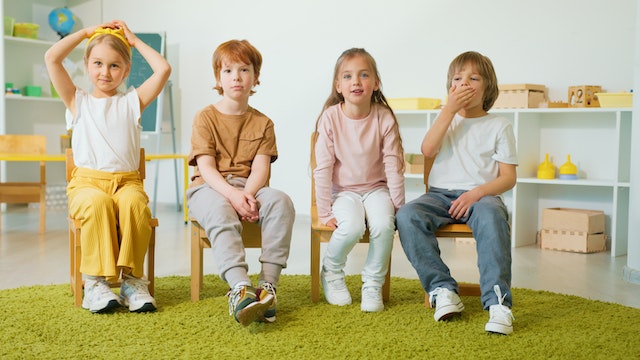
[0,205,640,308]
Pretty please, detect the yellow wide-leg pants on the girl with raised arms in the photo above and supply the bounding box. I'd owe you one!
[67,168,151,280]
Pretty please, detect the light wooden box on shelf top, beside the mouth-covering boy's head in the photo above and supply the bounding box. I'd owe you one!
[493,84,548,109]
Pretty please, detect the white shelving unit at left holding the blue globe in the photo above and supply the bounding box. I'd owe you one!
[0,0,102,183]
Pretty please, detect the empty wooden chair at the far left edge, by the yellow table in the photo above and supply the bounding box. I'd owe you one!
[0,135,47,234]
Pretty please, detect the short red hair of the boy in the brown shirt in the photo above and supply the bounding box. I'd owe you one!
[212,40,262,95]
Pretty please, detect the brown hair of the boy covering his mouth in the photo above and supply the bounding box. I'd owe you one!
[447,51,500,111]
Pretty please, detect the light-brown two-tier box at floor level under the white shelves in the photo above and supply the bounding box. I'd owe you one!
[540,208,606,253]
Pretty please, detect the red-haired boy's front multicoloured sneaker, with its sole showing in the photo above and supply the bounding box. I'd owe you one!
[227,284,274,326]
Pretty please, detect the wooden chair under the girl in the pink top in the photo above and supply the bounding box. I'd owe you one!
[311,133,391,303]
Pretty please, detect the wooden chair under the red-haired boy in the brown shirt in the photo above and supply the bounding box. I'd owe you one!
[191,219,262,302]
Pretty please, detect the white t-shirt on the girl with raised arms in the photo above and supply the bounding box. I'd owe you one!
[65,87,142,172]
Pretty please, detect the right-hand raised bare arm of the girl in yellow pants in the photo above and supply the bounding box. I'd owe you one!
[115,21,171,112]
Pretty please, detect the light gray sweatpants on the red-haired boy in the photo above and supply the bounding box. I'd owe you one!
[187,177,295,287]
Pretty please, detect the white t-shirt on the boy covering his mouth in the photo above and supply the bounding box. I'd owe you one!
[429,114,518,190]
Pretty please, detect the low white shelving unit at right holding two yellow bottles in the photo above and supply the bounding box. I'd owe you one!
[396,108,631,257]
